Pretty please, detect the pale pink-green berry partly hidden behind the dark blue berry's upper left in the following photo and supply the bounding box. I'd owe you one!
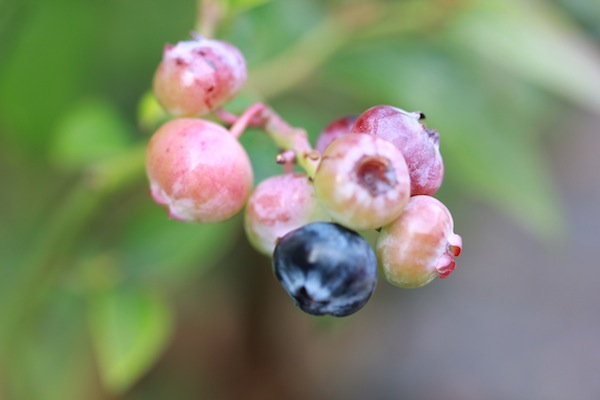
[244,173,329,256]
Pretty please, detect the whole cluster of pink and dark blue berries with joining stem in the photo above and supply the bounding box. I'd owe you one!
[146,36,462,316]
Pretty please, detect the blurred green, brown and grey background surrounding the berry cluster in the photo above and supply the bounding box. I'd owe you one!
[0,0,600,400]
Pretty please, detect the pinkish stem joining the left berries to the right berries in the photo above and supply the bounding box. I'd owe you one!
[226,103,321,178]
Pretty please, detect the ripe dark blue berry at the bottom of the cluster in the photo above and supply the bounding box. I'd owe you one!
[273,222,377,317]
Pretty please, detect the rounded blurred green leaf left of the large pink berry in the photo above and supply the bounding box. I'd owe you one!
[50,99,131,170]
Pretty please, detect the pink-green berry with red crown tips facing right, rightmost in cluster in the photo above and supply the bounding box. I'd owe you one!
[376,196,462,288]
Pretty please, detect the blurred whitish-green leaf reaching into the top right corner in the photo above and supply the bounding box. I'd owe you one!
[447,0,600,111]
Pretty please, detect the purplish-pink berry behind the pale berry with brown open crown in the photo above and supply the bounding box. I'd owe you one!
[352,106,444,196]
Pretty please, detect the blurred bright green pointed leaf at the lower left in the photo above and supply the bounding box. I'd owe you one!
[89,287,173,393]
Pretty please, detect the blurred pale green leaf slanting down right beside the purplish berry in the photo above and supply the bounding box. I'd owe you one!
[436,115,566,240]
